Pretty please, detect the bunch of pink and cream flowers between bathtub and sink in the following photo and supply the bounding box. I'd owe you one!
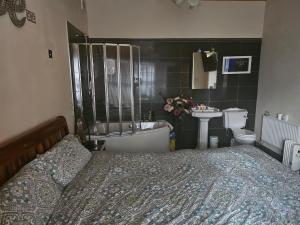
[164,96,194,118]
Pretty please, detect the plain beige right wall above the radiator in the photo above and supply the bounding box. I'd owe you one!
[255,0,300,139]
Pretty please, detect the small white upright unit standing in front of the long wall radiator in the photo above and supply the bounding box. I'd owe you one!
[282,140,300,171]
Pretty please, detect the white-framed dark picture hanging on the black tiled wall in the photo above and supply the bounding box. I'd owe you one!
[222,56,252,74]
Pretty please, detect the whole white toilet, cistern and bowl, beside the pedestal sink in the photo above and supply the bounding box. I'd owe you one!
[223,108,256,145]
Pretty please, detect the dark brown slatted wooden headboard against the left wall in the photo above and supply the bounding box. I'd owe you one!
[0,116,69,186]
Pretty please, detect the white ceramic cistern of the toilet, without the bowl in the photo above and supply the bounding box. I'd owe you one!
[223,108,248,129]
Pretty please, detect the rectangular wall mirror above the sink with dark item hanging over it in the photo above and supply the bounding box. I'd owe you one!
[192,49,218,89]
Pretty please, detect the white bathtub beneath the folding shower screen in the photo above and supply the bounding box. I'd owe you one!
[91,121,173,152]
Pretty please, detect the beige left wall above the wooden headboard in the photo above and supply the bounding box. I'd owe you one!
[0,0,87,142]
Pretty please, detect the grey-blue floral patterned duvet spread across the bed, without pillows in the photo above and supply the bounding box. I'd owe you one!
[49,146,300,225]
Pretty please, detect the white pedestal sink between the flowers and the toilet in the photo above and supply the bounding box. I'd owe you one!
[192,111,223,150]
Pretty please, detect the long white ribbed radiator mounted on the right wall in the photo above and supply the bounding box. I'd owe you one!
[261,116,300,155]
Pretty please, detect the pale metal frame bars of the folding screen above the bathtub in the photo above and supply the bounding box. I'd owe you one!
[71,43,141,136]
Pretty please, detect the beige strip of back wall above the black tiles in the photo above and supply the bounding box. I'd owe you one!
[87,0,265,38]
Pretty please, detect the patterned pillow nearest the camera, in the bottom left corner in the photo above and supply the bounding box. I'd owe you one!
[0,159,62,225]
